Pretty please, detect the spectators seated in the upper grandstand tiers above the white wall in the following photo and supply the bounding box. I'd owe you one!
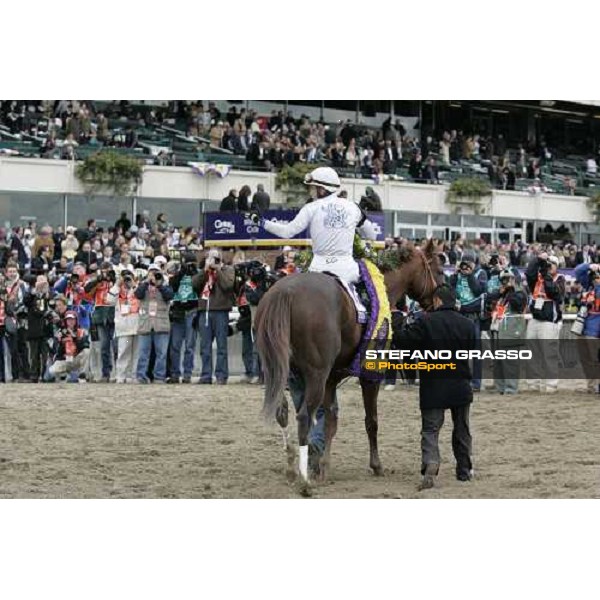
[0,100,597,194]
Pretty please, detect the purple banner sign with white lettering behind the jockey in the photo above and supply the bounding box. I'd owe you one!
[204,209,385,247]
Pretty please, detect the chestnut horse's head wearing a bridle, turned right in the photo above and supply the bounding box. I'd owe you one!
[383,239,444,310]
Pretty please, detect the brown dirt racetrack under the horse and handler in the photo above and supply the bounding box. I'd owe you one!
[0,381,600,498]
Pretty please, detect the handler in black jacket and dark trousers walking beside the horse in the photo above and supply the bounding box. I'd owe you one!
[394,285,476,490]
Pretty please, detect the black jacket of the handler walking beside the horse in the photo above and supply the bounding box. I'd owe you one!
[394,308,476,409]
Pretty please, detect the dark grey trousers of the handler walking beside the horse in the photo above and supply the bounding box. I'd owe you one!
[421,404,473,475]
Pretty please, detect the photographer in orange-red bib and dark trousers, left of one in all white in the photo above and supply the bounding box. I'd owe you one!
[83,262,117,383]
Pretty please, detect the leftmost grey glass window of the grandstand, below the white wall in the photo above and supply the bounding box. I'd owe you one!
[0,192,64,227]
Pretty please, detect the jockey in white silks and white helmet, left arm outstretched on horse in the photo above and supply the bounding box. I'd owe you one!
[251,167,376,284]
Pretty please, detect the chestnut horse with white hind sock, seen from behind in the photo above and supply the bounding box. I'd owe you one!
[255,240,443,485]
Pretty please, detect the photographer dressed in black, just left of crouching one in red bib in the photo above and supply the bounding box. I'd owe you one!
[24,275,53,383]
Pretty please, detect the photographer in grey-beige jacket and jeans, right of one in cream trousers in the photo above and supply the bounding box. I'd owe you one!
[135,264,173,383]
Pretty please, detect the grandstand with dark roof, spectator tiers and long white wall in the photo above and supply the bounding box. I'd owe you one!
[0,100,600,242]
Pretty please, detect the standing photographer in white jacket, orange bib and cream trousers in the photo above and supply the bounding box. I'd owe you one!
[108,269,140,383]
